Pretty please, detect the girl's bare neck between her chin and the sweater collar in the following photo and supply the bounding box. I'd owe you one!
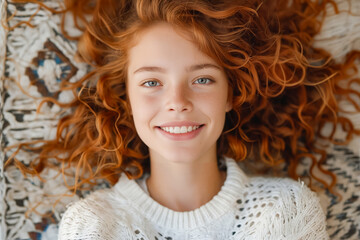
[147,154,226,212]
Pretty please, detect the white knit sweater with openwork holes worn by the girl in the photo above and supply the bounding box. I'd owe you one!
[59,159,329,240]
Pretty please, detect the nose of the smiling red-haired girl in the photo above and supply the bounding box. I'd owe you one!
[166,84,193,112]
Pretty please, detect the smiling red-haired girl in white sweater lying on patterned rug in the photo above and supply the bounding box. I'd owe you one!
[8,0,355,239]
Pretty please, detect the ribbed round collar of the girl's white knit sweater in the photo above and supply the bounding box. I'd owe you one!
[114,158,248,230]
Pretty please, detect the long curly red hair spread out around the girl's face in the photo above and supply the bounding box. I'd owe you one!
[7,0,360,197]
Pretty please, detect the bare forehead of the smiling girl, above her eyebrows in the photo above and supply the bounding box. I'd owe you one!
[128,22,216,71]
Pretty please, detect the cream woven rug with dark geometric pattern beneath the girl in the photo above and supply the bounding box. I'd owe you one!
[0,0,360,240]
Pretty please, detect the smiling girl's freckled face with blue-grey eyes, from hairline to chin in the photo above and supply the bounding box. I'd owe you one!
[127,23,231,162]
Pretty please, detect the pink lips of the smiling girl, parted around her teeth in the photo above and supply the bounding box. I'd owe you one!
[156,121,205,141]
